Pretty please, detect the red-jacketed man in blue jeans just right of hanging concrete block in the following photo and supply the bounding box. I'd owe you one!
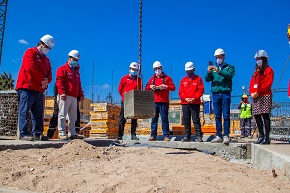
[145,61,175,141]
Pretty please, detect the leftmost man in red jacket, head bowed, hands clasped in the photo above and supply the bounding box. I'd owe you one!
[16,35,54,141]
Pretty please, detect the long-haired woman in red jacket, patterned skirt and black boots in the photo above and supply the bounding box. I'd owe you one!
[249,50,274,144]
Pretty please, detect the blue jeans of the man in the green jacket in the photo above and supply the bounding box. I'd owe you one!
[212,92,231,138]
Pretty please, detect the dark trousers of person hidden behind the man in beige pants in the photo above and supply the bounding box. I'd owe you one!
[47,96,81,138]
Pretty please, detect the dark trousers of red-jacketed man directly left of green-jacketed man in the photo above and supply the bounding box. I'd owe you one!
[182,104,202,138]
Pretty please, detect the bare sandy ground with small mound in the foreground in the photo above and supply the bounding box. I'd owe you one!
[0,140,290,193]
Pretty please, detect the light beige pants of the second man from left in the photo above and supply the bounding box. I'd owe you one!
[57,95,78,136]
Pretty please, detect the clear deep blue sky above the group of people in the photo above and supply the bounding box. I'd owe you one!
[0,0,290,104]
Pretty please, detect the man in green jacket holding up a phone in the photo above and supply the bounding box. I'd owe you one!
[205,48,235,144]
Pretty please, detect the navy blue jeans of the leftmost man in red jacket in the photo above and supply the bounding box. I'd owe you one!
[17,89,44,137]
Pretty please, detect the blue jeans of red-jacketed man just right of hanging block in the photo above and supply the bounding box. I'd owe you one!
[151,102,169,138]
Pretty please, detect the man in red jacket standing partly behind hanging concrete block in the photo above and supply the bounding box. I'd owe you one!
[117,62,142,140]
